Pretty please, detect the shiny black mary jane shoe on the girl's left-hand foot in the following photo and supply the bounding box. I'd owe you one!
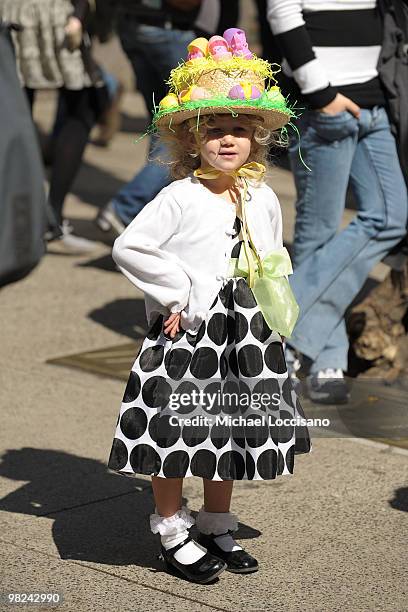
[159,536,227,584]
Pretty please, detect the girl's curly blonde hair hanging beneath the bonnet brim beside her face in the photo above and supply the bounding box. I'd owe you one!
[154,114,282,180]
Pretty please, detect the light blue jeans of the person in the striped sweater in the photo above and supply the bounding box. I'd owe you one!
[288,107,408,373]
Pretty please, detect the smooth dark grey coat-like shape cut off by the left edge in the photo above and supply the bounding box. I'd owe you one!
[0,20,45,286]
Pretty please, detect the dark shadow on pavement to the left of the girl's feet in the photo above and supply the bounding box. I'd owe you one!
[0,448,260,571]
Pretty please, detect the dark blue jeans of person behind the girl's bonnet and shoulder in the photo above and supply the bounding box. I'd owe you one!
[112,23,195,225]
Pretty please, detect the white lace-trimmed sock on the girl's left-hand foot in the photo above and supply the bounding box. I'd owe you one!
[150,506,206,565]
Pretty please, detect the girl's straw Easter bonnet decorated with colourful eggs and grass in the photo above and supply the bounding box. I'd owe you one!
[153,28,293,132]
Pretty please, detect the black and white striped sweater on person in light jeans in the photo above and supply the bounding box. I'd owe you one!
[268,0,384,108]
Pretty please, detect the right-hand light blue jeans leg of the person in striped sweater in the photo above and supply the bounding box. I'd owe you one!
[290,108,408,401]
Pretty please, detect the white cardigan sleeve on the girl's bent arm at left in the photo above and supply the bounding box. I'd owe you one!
[112,193,191,313]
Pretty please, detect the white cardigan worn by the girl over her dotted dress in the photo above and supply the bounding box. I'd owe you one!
[112,176,282,334]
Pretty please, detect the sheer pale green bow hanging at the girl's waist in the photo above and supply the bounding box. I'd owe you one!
[228,247,299,338]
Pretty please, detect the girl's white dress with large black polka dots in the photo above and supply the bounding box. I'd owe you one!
[108,217,311,480]
